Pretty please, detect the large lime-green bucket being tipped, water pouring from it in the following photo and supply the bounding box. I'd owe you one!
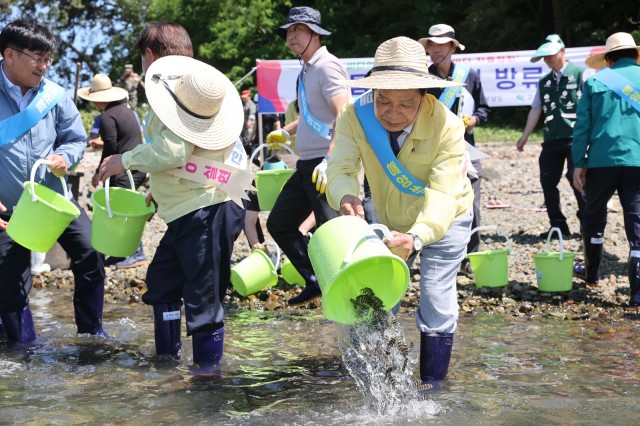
[309,216,409,324]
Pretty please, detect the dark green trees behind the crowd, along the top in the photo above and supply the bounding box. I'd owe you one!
[0,0,640,135]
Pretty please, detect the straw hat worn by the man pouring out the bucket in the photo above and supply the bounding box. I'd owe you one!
[340,37,463,90]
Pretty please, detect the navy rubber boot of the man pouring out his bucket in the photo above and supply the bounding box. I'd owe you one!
[420,332,453,384]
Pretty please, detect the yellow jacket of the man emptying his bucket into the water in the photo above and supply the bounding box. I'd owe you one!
[327,95,473,244]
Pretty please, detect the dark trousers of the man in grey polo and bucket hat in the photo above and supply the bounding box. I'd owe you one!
[267,158,338,283]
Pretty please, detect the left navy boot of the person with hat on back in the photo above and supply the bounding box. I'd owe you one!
[153,302,182,358]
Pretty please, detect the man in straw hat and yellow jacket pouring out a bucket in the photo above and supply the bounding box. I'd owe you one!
[327,37,473,383]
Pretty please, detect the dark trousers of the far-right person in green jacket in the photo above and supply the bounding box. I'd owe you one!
[582,167,640,250]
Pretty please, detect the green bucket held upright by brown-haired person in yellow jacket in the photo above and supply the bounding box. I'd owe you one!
[91,170,155,257]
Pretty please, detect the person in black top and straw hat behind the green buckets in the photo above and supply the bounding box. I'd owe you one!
[78,74,147,268]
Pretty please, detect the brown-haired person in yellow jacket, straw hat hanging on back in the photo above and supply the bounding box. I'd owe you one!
[99,23,253,371]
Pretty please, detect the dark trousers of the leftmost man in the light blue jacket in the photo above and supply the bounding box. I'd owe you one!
[0,200,105,312]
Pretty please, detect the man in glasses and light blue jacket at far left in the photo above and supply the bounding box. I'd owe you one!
[0,19,106,342]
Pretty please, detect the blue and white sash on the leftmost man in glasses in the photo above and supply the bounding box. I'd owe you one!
[0,81,64,146]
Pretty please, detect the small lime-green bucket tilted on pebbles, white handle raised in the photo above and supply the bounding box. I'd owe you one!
[231,241,280,297]
